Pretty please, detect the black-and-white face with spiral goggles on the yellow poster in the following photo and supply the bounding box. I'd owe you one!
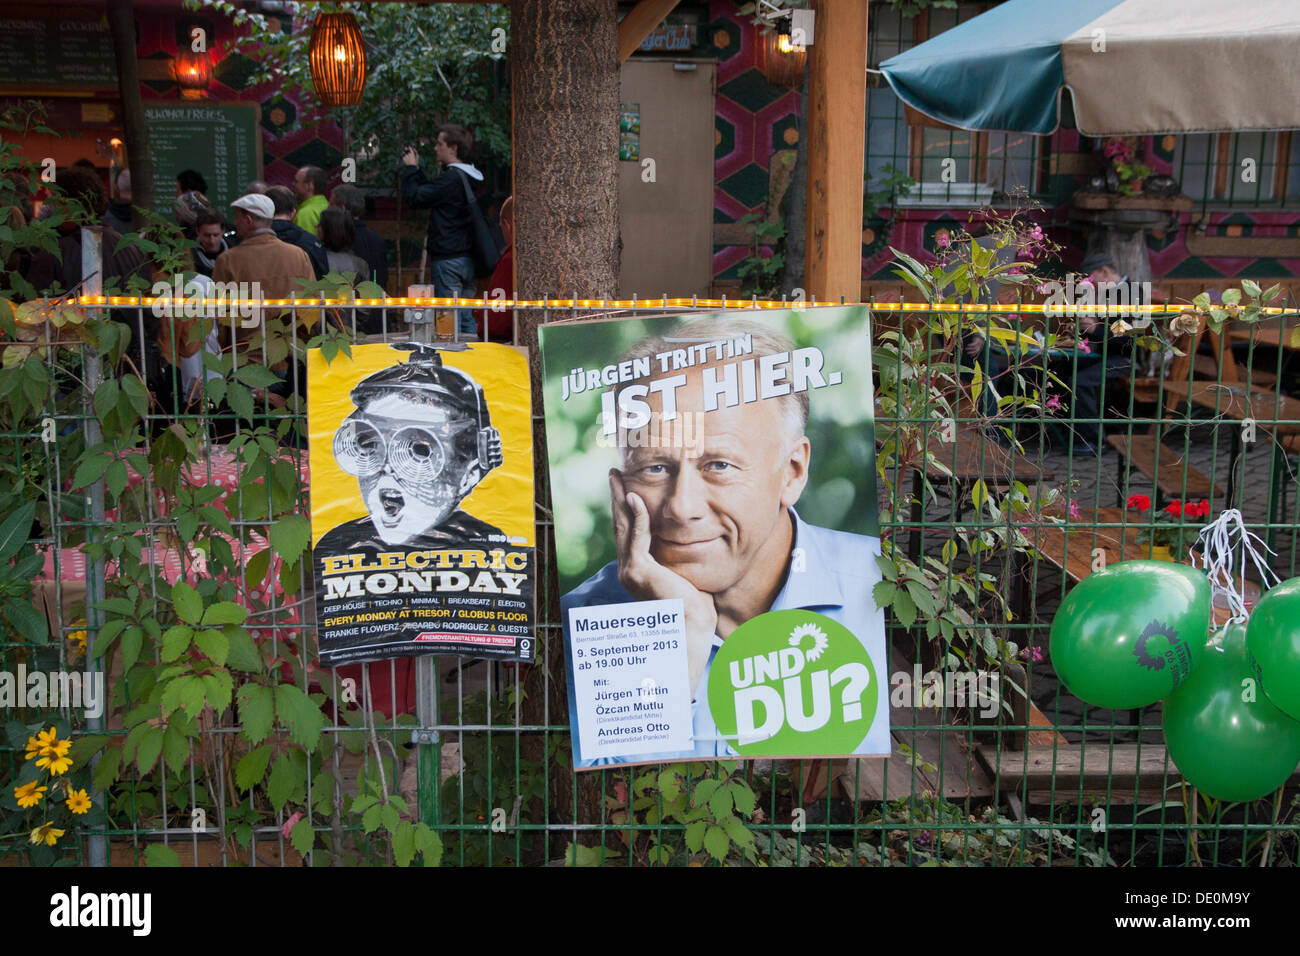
[335,394,477,545]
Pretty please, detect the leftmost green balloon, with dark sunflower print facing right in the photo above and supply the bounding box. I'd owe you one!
[1050,561,1210,710]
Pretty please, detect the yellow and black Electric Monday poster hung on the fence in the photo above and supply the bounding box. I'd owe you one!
[307,343,536,666]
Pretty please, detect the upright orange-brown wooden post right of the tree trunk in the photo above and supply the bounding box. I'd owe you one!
[805,0,867,302]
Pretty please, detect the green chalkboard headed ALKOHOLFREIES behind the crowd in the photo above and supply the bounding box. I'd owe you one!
[144,103,261,219]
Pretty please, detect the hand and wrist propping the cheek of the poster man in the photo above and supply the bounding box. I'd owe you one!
[610,468,718,698]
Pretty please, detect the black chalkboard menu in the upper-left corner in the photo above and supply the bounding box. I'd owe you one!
[0,17,117,86]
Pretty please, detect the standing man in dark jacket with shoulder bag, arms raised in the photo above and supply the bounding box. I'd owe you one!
[402,124,495,336]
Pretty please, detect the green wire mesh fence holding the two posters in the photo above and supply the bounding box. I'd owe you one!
[0,290,1300,865]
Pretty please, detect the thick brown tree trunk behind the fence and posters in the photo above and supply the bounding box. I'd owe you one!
[510,0,619,853]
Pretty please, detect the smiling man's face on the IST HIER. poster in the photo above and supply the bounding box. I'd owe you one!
[620,368,810,593]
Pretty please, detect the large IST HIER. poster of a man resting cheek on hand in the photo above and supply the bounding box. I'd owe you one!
[541,307,889,769]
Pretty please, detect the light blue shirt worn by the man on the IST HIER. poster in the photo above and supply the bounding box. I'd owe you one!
[560,509,889,767]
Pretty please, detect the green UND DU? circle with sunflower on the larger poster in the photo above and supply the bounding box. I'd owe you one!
[709,610,878,757]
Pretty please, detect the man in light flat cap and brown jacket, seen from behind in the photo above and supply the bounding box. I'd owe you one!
[212,194,315,363]
